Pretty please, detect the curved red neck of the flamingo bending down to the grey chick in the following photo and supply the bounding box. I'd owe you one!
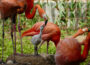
[25,0,45,19]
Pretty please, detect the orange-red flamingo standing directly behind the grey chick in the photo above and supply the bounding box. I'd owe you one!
[22,22,61,53]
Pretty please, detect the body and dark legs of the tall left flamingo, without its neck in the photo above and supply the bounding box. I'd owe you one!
[0,0,26,62]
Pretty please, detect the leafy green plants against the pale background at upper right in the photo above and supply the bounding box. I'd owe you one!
[55,1,90,28]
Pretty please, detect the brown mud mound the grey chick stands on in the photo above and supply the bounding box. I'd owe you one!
[0,55,55,65]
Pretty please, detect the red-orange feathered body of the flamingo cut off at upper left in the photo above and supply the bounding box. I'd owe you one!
[0,0,26,19]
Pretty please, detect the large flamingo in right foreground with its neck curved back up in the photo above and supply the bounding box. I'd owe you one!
[55,28,90,65]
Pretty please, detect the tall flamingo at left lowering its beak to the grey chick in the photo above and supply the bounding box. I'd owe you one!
[0,0,47,61]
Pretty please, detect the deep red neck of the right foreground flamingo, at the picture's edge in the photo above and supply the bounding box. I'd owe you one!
[81,33,90,61]
